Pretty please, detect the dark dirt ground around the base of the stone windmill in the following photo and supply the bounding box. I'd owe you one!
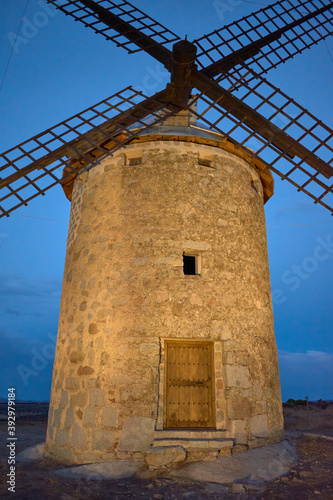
[0,404,333,500]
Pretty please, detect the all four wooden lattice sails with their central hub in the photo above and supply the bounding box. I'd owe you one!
[0,0,333,216]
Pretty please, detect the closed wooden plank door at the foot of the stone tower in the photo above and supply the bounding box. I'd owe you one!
[164,341,215,429]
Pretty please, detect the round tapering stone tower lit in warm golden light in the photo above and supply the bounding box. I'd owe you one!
[47,112,283,463]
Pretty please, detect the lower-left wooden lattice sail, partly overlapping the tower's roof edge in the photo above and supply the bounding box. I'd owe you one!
[0,87,178,218]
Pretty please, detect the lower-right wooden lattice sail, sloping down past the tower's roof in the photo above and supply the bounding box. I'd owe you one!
[189,65,333,213]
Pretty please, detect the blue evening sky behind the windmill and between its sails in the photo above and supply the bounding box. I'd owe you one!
[0,0,333,400]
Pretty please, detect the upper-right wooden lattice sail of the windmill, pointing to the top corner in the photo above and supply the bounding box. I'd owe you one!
[194,0,333,77]
